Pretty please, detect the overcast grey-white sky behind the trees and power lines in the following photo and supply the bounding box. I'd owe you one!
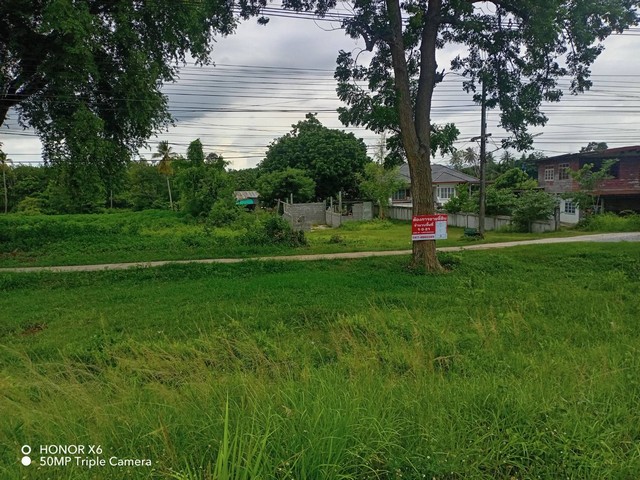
[0,7,640,169]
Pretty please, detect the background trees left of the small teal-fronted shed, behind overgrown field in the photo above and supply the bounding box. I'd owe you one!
[2,140,256,221]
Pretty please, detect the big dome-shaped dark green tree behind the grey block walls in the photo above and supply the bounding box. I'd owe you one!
[259,113,370,198]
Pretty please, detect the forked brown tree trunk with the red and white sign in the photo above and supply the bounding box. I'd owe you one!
[386,0,443,272]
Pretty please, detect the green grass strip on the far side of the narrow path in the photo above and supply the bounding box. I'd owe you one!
[0,211,592,268]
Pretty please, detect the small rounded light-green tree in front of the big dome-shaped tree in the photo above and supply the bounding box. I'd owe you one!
[258,168,316,206]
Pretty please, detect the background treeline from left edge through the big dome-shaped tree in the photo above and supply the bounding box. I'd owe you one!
[0,114,371,216]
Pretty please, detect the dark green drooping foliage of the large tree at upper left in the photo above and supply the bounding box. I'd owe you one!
[0,0,265,176]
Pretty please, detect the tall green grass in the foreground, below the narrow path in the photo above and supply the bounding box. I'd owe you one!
[0,246,640,480]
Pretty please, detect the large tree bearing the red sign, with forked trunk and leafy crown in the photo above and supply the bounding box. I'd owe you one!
[285,0,640,270]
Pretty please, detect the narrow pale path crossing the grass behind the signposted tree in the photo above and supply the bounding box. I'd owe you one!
[0,232,640,273]
